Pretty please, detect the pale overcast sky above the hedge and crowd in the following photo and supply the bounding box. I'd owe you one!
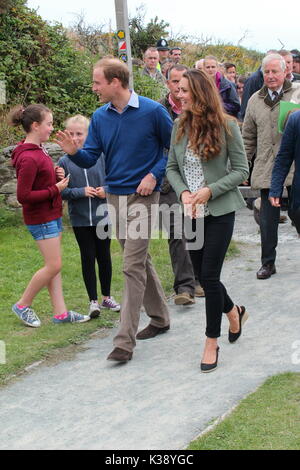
[27,0,300,52]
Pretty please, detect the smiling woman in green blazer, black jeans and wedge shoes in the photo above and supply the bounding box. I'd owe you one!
[167,69,248,372]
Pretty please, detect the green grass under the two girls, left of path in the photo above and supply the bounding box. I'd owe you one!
[0,222,173,384]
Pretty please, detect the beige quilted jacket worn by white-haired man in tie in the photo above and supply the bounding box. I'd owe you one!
[242,80,300,189]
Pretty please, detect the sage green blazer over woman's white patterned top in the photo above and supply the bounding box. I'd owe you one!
[167,119,249,216]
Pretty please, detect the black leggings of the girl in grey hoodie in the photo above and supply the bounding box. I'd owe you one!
[73,226,112,301]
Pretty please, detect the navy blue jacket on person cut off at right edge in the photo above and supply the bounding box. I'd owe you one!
[269,111,300,210]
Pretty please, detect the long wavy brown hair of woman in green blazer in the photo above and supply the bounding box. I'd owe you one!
[176,69,230,160]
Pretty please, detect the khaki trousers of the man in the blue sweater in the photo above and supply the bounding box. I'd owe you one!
[107,192,170,352]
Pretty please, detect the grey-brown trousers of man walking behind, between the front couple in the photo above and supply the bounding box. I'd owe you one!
[159,189,195,296]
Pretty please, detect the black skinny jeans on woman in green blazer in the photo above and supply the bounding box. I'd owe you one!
[190,212,235,338]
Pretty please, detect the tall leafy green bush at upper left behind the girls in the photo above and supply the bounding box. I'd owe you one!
[0,0,97,136]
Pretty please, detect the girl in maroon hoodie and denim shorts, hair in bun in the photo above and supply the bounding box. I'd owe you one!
[9,104,90,328]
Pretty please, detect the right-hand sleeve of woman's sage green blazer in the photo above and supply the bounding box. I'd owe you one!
[208,121,249,199]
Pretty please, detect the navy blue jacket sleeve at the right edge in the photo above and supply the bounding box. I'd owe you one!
[269,115,297,197]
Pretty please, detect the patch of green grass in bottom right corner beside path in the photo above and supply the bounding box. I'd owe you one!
[189,373,300,450]
